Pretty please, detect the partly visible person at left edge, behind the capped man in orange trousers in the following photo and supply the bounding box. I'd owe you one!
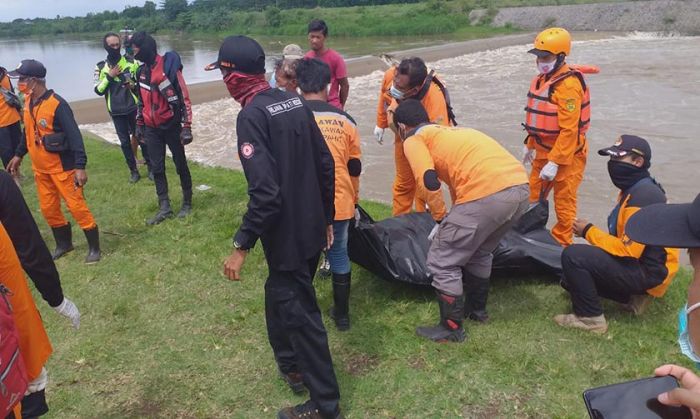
[0,67,22,174]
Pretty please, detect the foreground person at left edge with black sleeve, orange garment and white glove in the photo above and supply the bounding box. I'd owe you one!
[0,171,80,419]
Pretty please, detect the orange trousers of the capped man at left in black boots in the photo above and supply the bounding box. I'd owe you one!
[34,170,97,230]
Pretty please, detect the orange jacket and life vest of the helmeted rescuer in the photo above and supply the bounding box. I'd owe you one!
[524,64,590,165]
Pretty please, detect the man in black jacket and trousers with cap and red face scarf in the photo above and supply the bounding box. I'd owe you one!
[215,36,342,419]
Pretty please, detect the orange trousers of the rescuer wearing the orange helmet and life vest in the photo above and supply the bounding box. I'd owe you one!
[530,152,586,246]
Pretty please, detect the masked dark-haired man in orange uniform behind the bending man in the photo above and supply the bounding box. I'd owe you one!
[375,57,456,217]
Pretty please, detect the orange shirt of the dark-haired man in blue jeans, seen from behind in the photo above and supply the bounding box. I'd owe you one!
[307,100,362,221]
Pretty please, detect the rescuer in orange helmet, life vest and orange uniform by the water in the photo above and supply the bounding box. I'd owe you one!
[523,28,591,246]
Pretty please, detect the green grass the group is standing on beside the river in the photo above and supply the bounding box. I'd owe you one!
[17,139,689,418]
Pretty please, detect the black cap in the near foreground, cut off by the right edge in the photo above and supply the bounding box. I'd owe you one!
[625,195,700,249]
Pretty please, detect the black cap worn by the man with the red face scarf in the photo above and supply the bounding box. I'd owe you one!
[205,35,265,74]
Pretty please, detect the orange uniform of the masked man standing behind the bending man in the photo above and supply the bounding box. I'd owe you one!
[377,72,450,217]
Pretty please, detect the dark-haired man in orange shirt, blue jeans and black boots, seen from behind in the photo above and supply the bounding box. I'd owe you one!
[296,59,362,331]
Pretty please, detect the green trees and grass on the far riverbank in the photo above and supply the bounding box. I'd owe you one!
[0,0,636,38]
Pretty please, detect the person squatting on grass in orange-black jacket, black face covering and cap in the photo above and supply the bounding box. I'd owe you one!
[554,135,678,333]
